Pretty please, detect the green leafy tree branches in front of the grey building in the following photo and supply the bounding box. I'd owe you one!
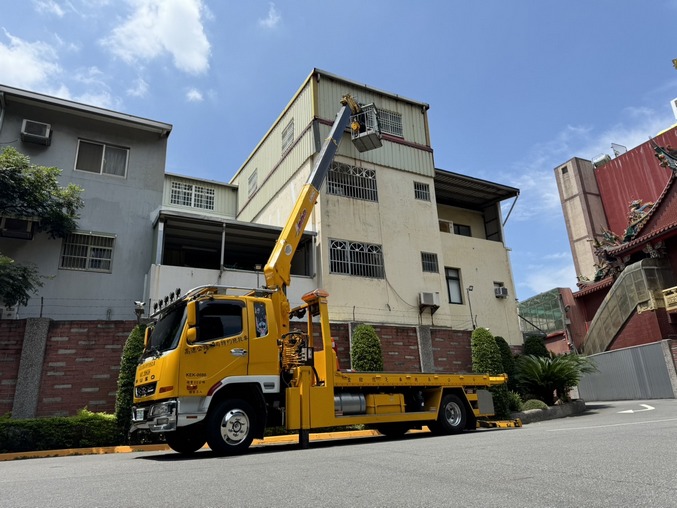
[0,147,83,306]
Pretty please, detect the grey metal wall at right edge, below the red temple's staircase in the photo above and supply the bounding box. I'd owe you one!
[578,341,675,401]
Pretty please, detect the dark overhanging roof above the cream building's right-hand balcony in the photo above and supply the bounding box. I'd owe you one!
[435,168,519,210]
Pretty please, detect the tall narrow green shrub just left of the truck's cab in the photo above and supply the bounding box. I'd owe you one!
[115,325,146,440]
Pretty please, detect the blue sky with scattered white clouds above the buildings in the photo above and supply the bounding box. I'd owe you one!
[0,0,677,301]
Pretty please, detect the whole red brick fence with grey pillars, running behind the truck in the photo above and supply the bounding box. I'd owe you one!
[0,319,472,417]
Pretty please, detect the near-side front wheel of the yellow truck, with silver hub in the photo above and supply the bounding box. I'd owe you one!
[207,399,256,455]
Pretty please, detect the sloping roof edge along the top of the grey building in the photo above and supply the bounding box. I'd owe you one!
[0,84,172,137]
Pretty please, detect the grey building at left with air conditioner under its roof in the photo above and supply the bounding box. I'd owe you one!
[0,86,172,321]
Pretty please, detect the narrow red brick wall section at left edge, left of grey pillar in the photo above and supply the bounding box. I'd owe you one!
[0,320,26,415]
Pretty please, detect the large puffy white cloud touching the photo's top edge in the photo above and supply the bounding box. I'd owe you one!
[101,0,210,74]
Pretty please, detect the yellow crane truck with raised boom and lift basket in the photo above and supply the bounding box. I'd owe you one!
[131,96,507,455]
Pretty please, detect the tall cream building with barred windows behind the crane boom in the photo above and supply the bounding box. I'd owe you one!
[231,69,521,344]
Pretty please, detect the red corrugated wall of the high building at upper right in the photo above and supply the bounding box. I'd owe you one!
[595,128,677,238]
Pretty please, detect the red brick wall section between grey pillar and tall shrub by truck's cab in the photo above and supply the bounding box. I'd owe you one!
[37,321,136,416]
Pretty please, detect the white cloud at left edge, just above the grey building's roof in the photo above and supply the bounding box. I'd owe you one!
[0,28,62,93]
